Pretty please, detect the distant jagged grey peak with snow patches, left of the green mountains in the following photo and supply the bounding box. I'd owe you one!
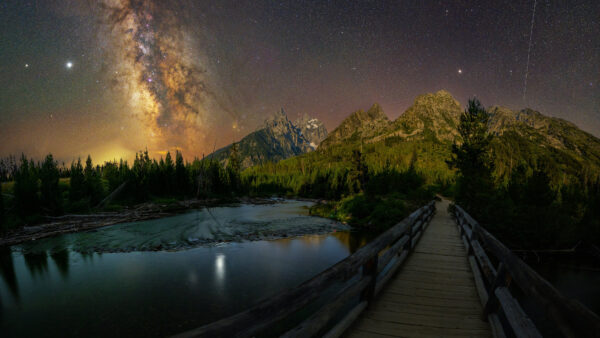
[208,108,327,168]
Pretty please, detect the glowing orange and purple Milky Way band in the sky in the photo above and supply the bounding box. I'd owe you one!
[101,0,233,153]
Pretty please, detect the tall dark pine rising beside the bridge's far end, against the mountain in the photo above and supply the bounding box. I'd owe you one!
[448,99,494,220]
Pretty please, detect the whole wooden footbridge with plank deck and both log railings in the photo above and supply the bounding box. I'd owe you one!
[177,201,600,337]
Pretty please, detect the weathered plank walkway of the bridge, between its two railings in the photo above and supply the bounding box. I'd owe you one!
[346,201,491,337]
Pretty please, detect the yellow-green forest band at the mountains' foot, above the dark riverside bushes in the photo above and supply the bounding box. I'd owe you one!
[242,137,454,200]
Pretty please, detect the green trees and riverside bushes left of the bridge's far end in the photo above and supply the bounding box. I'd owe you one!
[242,146,441,231]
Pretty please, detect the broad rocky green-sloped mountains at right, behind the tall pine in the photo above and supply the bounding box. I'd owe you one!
[310,90,600,183]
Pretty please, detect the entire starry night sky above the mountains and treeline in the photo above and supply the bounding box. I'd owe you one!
[0,0,600,162]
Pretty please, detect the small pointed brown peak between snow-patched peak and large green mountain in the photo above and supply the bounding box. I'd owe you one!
[321,103,391,148]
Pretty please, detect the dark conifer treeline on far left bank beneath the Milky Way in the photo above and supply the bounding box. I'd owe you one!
[0,146,245,227]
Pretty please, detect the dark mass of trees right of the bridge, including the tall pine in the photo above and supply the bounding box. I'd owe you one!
[449,100,600,249]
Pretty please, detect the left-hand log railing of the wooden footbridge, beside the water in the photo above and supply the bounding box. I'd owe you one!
[175,201,435,337]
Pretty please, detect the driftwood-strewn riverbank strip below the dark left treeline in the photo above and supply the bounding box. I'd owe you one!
[0,197,282,247]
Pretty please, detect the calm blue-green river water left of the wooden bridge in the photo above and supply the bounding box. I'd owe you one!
[0,202,366,337]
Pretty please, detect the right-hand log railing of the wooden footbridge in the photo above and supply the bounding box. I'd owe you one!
[455,205,600,337]
